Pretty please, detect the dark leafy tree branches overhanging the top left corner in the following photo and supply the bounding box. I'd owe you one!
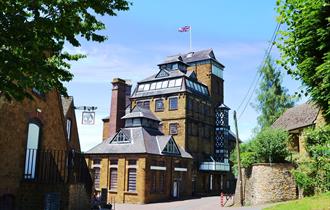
[0,0,130,100]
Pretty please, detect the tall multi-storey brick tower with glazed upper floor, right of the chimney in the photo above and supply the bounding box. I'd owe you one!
[131,49,235,193]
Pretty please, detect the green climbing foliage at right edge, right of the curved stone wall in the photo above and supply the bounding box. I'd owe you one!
[293,125,330,195]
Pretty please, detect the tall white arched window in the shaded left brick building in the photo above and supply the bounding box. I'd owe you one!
[24,122,41,179]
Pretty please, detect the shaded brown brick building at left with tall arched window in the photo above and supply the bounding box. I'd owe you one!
[0,90,92,210]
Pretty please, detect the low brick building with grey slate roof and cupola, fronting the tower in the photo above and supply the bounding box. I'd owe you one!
[86,106,193,203]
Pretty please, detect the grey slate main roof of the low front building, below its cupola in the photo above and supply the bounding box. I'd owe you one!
[86,127,192,158]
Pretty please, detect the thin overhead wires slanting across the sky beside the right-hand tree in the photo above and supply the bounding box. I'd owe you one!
[237,23,281,119]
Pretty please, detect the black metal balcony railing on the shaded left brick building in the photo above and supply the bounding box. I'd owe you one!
[22,149,93,192]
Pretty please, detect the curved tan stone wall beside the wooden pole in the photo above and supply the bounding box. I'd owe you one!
[242,163,297,205]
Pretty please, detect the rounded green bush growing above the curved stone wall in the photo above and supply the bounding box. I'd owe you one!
[230,128,290,175]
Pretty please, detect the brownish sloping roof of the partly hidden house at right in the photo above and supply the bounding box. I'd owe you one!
[272,103,320,131]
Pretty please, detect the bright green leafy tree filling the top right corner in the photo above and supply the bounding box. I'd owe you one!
[276,0,330,122]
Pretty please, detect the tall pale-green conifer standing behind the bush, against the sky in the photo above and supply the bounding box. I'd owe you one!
[253,57,294,130]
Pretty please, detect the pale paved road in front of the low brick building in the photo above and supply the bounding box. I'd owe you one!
[115,196,262,210]
